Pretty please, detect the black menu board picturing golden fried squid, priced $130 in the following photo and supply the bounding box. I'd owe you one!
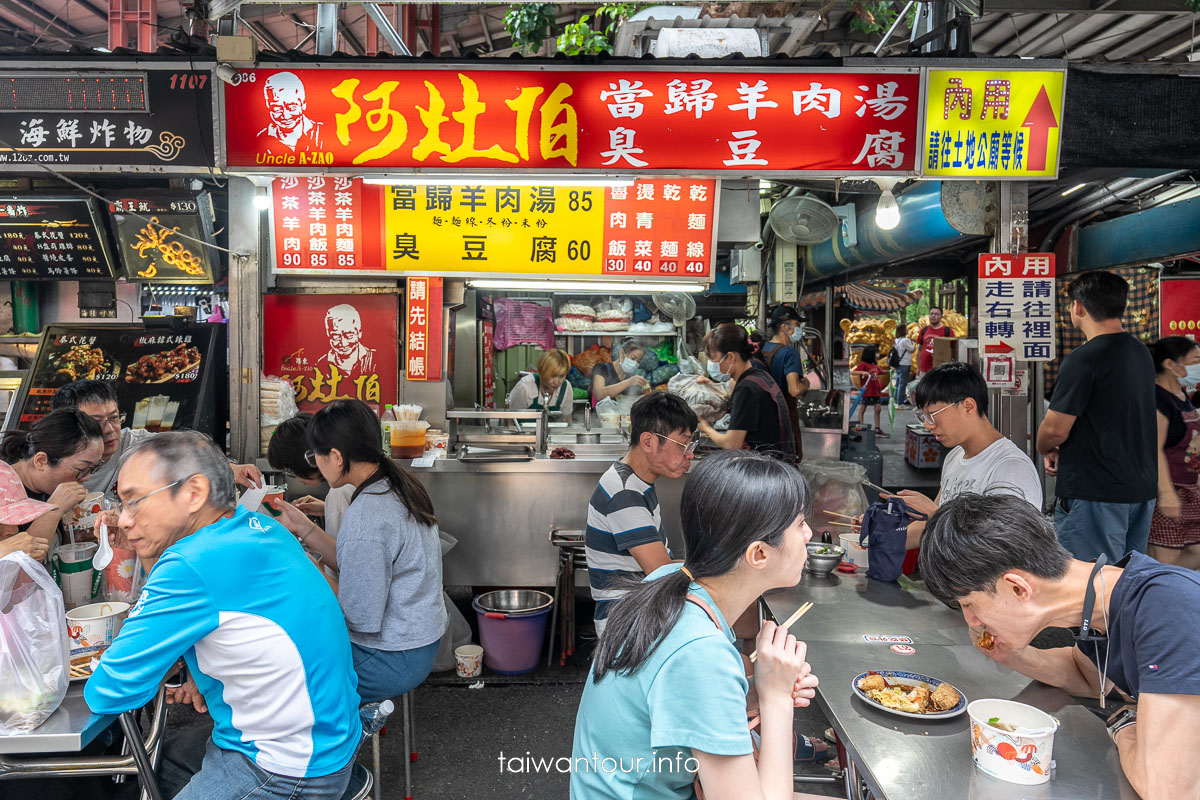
[108,193,212,284]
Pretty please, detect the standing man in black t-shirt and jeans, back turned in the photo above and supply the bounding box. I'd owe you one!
[1037,271,1158,563]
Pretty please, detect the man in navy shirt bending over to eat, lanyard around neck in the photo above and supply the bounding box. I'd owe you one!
[920,494,1200,800]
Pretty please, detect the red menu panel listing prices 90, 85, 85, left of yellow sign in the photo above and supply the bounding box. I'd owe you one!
[271,175,380,272]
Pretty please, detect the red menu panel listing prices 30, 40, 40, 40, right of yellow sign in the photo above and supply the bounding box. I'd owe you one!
[602,180,716,279]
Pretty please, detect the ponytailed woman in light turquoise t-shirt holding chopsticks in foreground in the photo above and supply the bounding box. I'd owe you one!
[571,452,817,800]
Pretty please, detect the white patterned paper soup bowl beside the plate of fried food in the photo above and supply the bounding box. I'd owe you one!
[967,700,1058,786]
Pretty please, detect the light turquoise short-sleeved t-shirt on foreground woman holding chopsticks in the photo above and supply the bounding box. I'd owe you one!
[571,564,754,800]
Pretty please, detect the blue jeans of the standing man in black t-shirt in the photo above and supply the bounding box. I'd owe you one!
[1054,498,1154,564]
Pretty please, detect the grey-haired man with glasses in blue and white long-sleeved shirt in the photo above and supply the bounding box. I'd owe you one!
[84,431,362,800]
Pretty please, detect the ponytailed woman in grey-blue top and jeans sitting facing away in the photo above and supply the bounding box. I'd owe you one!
[272,399,446,703]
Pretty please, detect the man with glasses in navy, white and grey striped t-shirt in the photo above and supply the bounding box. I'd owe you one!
[584,392,698,636]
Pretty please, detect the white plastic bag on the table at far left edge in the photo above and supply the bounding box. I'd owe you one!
[0,553,71,735]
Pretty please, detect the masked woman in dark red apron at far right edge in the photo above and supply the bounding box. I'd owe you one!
[1150,336,1200,570]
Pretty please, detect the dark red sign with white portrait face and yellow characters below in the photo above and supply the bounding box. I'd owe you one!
[263,294,400,411]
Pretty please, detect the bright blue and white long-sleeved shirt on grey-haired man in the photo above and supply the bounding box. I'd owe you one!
[84,509,362,777]
